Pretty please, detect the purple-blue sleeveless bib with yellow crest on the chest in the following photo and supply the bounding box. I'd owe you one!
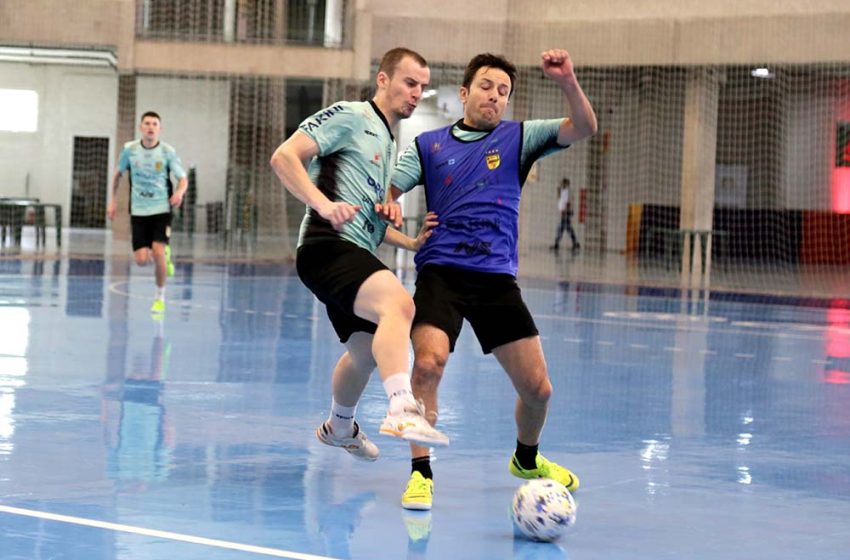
[414,121,528,276]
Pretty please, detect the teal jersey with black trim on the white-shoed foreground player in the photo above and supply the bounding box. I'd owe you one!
[298,101,398,253]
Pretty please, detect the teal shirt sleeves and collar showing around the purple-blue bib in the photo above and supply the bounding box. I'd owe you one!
[392,119,567,192]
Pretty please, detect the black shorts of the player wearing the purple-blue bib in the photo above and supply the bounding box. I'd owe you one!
[413,265,538,354]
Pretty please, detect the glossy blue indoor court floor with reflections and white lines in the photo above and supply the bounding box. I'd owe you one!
[0,243,850,560]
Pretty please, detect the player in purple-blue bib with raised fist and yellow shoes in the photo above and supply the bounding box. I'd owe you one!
[392,49,597,510]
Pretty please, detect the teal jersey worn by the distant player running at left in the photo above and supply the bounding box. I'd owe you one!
[118,140,186,216]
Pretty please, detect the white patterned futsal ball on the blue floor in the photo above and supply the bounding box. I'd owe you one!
[511,478,577,541]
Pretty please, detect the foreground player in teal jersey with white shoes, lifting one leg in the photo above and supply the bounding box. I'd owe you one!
[271,48,448,461]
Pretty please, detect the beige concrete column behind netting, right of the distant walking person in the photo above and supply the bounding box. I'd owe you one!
[679,68,722,287]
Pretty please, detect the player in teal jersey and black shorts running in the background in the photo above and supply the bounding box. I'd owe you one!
[106,111,189,313]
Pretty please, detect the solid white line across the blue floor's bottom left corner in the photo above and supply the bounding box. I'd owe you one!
[0,506,334,560]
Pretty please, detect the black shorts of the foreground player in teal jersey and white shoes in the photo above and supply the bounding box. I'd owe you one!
[295,240,389,344]
